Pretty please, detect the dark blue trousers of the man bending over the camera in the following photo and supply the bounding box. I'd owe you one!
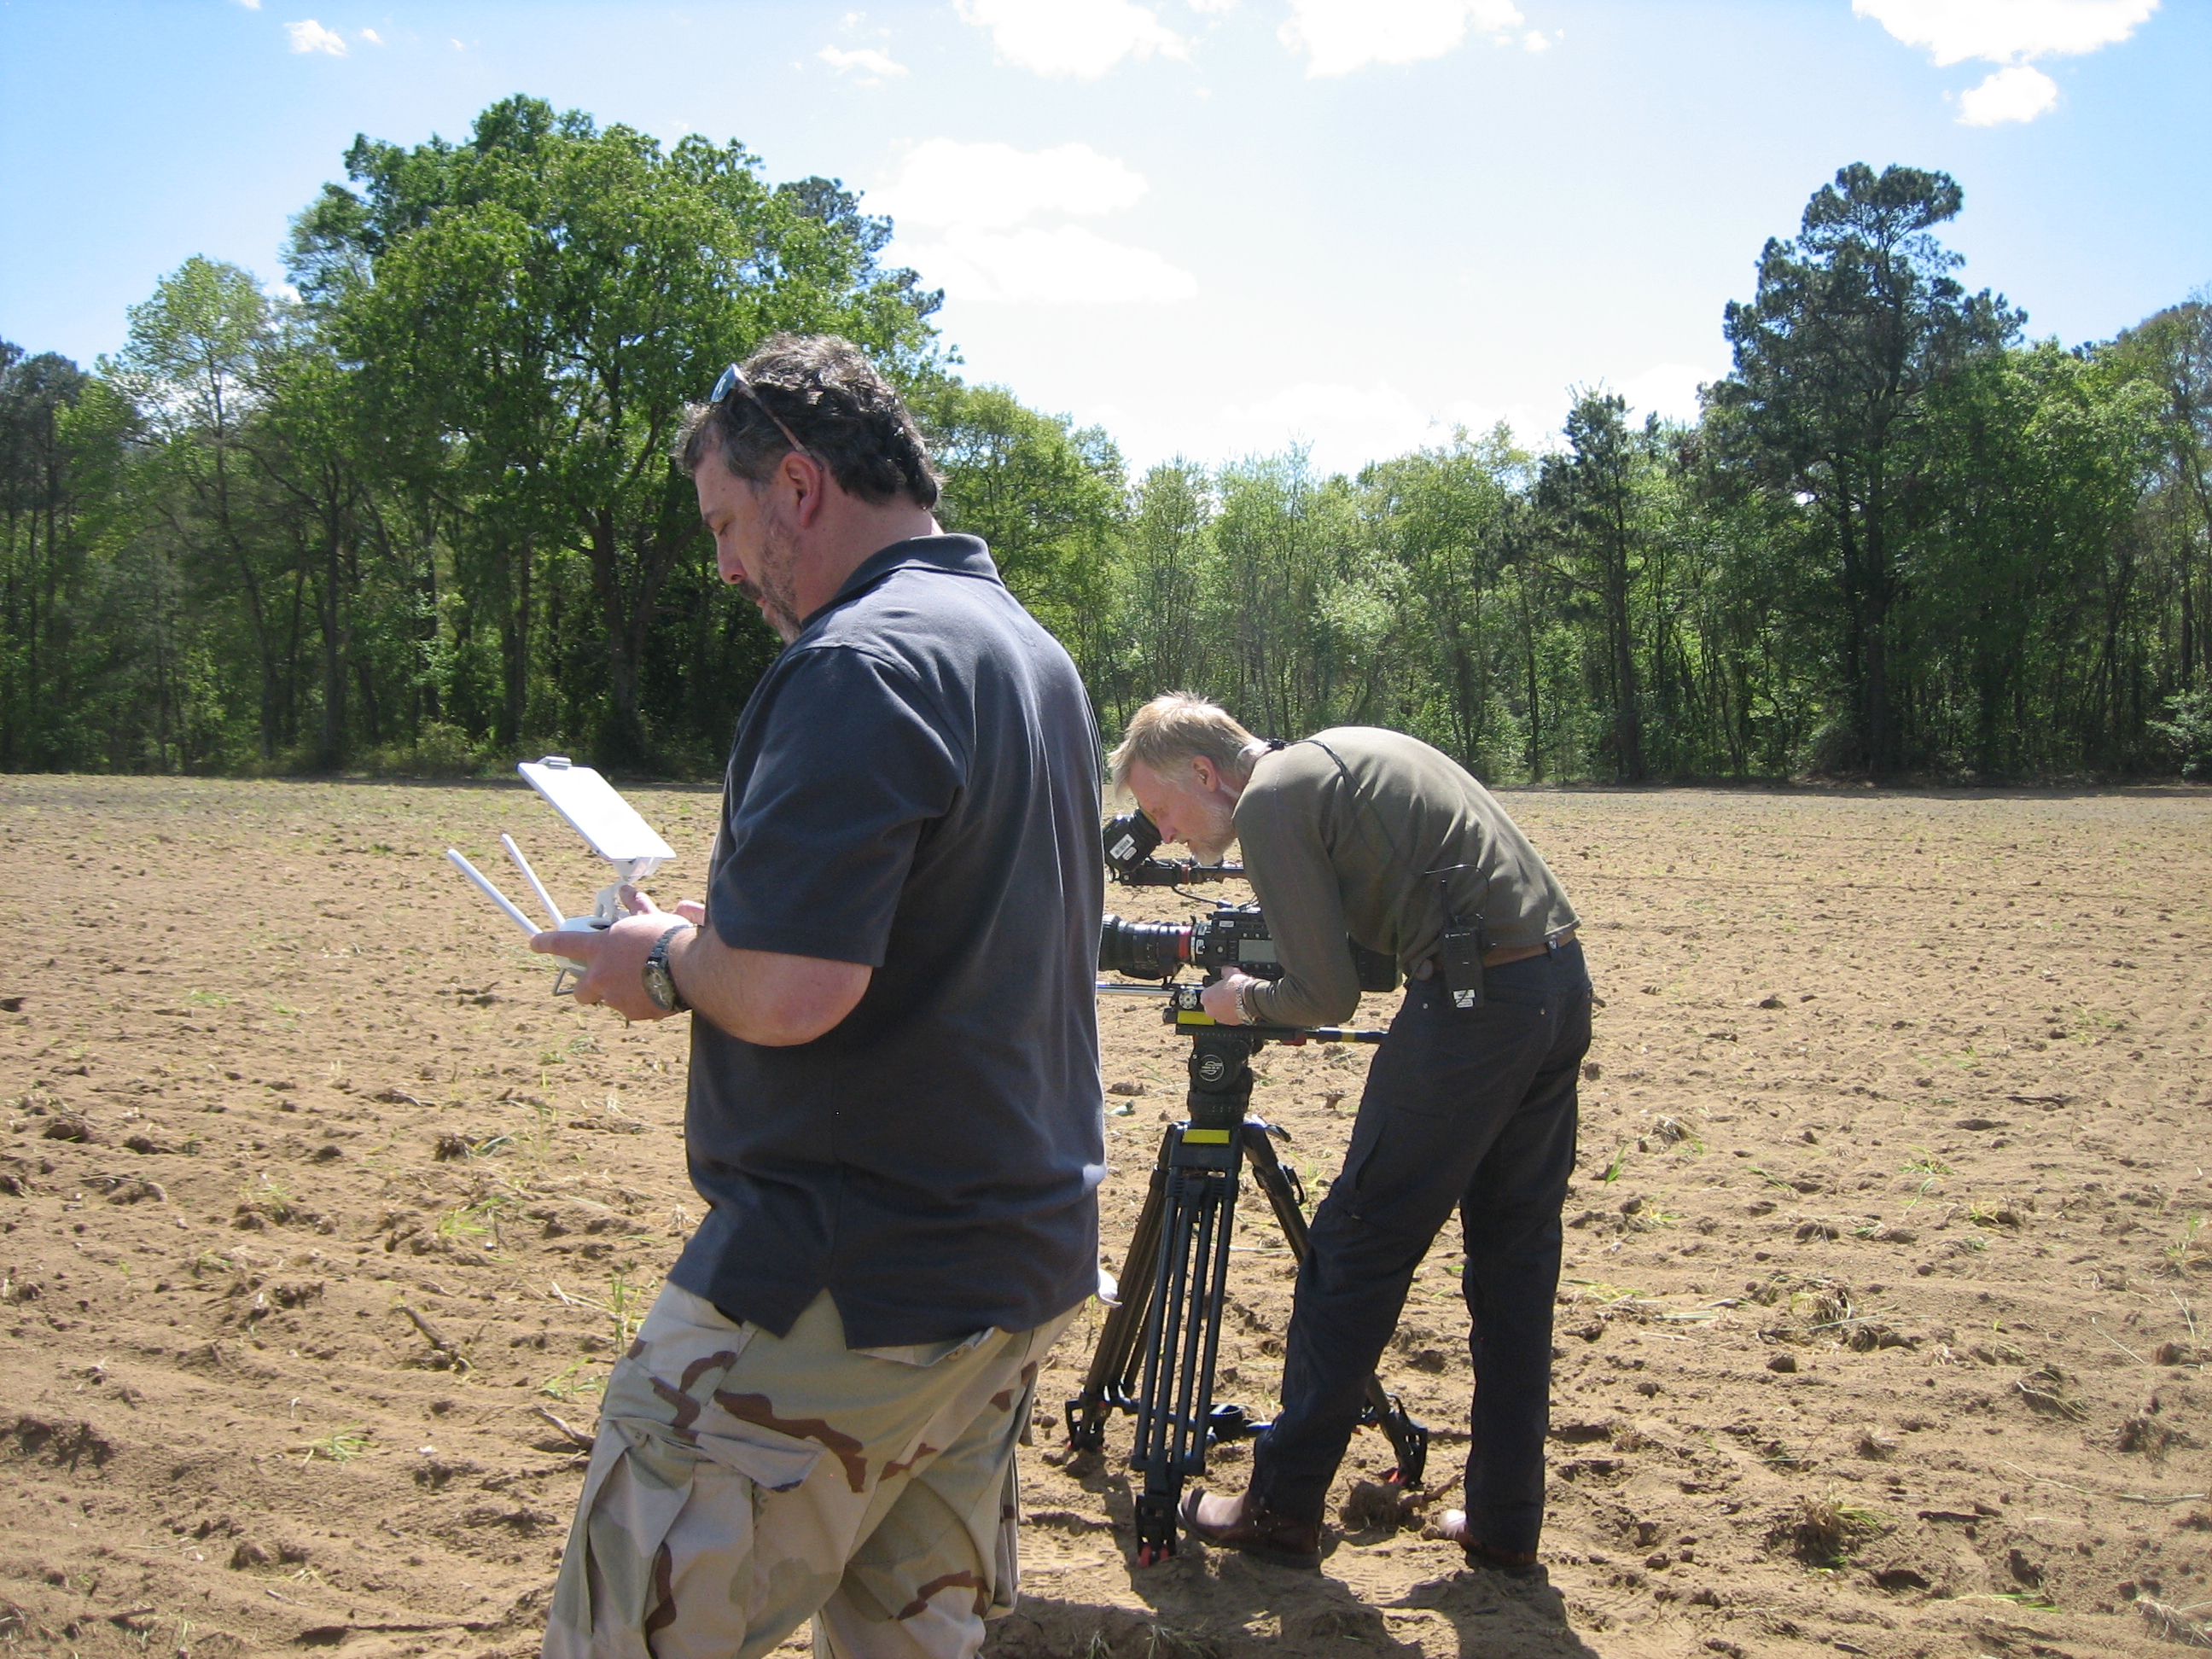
[1252,945,1591,1551]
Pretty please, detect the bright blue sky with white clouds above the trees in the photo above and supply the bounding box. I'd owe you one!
[0,0,2212,467]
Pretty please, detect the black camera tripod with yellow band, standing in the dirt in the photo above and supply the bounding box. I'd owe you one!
[1068,984,1429,1566]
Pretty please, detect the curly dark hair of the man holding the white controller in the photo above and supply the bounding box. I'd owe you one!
[677,334,938,507]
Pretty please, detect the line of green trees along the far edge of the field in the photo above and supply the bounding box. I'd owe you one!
[0,97,2212,781]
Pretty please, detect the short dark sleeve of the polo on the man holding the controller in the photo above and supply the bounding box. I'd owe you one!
[707,646,964,967]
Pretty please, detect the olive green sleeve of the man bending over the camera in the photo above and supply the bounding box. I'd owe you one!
[1237,788,1360,1027]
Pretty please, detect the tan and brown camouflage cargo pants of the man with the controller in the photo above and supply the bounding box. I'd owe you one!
[544,1285,1075,1659]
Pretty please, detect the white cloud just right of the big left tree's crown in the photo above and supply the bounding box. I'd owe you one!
[867,139,1199,306]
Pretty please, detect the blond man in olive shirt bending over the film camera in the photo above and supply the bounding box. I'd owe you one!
[1113,692,1591,1573]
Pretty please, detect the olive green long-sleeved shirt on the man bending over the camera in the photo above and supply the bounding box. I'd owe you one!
[1237,725,1575,1027]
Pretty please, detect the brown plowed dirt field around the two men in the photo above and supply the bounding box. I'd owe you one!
[0,777,2212,1659]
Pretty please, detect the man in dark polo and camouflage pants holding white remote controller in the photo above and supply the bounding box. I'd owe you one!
[538,336,1103,1659]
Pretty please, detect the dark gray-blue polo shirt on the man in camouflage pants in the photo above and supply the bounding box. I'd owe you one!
[670,535,1106,1348]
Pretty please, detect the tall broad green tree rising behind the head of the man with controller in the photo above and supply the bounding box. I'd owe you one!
[292,97,935,763]
